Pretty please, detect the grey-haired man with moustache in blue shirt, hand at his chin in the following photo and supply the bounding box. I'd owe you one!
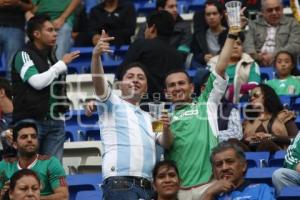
[203,142,275,200]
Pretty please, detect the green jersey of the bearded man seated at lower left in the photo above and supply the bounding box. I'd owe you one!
[0,155,66,196]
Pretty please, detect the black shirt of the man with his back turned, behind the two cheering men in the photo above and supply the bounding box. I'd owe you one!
[117,37,184,100]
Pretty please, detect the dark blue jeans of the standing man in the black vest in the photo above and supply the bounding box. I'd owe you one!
[37,119,65,160]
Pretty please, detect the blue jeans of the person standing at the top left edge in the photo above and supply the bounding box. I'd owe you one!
[0,26,25,79]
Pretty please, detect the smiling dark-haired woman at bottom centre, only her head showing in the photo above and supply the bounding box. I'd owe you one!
[153,160,180,200]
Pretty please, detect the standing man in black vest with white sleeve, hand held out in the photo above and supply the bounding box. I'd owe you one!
[12,15,79,159]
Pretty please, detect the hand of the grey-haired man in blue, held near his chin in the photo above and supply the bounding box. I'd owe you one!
[206,179,235,197]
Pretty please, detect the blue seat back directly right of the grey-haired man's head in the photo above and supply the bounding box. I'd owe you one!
[245,152,270,168]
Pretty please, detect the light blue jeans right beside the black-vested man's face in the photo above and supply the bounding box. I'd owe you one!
[56,23,72,60]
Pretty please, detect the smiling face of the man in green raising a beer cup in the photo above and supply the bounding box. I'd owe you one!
[166,72,194,103]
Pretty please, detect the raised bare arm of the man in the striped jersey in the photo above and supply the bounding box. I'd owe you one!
[91,30,114,98]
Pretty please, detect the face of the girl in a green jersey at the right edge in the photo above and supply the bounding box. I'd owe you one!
[275,53,294,79]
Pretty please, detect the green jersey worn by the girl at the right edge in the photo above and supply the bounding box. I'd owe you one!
[267,76,300,95]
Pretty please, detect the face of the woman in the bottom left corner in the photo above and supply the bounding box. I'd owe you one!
[9,176,40,200]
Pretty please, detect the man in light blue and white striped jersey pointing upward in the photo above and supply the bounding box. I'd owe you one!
[91,31,171,200]
